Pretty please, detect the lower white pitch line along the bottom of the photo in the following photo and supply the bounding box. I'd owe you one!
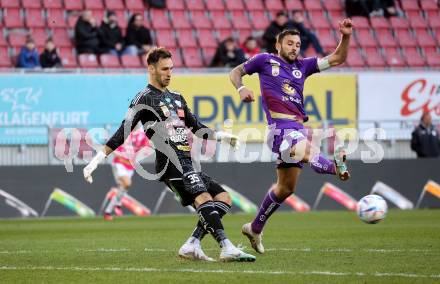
[0,266,440,278]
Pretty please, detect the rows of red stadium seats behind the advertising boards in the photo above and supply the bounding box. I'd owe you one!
[0,0,440,68]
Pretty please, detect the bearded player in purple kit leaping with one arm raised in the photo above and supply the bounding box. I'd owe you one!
[229,19,353,253]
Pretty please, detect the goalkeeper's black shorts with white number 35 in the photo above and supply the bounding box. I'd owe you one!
[163,171,226,206]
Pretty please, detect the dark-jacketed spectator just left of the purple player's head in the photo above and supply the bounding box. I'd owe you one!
[211,37,246,67]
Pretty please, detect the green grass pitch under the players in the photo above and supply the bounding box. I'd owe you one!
[0,210,440,284]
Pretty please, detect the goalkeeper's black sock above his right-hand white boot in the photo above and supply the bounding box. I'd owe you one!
[197,201,226,244]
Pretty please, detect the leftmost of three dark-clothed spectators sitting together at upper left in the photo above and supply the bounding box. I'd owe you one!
[75,10,99,54]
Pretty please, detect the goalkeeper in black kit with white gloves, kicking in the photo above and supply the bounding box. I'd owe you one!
[83,48,255,262]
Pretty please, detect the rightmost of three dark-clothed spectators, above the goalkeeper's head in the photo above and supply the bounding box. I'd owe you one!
[124,14,153,55]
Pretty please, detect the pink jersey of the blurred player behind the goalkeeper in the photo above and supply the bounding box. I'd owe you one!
[112,129,152,170]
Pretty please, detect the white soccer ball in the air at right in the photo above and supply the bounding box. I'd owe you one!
[357,194,388,224]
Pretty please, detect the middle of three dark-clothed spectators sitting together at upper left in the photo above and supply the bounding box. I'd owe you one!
[99,11,124,55]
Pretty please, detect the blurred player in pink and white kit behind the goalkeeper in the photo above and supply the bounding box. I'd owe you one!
[104,127,153,221]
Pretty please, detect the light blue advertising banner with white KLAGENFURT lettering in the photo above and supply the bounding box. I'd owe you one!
[0,74,146,144]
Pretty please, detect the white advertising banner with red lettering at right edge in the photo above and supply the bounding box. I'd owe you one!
[358,72,440,121]
